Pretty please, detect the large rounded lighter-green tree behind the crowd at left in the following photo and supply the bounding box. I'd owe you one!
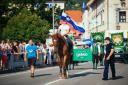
[3,9,50,41]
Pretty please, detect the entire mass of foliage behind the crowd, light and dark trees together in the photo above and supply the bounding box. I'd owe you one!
[0,0,62,41]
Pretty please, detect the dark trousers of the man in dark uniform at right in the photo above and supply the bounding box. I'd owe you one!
[103,59,115,79]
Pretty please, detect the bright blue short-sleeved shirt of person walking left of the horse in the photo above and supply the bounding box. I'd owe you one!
[26,44,37,58]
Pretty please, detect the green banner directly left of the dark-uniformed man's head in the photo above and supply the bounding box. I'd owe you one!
[91,32,104,43]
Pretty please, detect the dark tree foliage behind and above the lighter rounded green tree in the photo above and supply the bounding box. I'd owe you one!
[0,0,62,39]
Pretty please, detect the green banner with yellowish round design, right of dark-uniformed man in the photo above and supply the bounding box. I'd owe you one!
[111,32,124,46]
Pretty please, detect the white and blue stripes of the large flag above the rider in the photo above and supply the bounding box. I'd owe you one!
[60,12,85,33]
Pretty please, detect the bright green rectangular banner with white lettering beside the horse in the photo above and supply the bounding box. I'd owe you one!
[73,48,92,61]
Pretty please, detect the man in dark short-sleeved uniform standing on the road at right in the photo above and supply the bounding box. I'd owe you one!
[102,37,116,80]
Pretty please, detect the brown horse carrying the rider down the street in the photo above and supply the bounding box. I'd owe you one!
[52,33,71,79]
